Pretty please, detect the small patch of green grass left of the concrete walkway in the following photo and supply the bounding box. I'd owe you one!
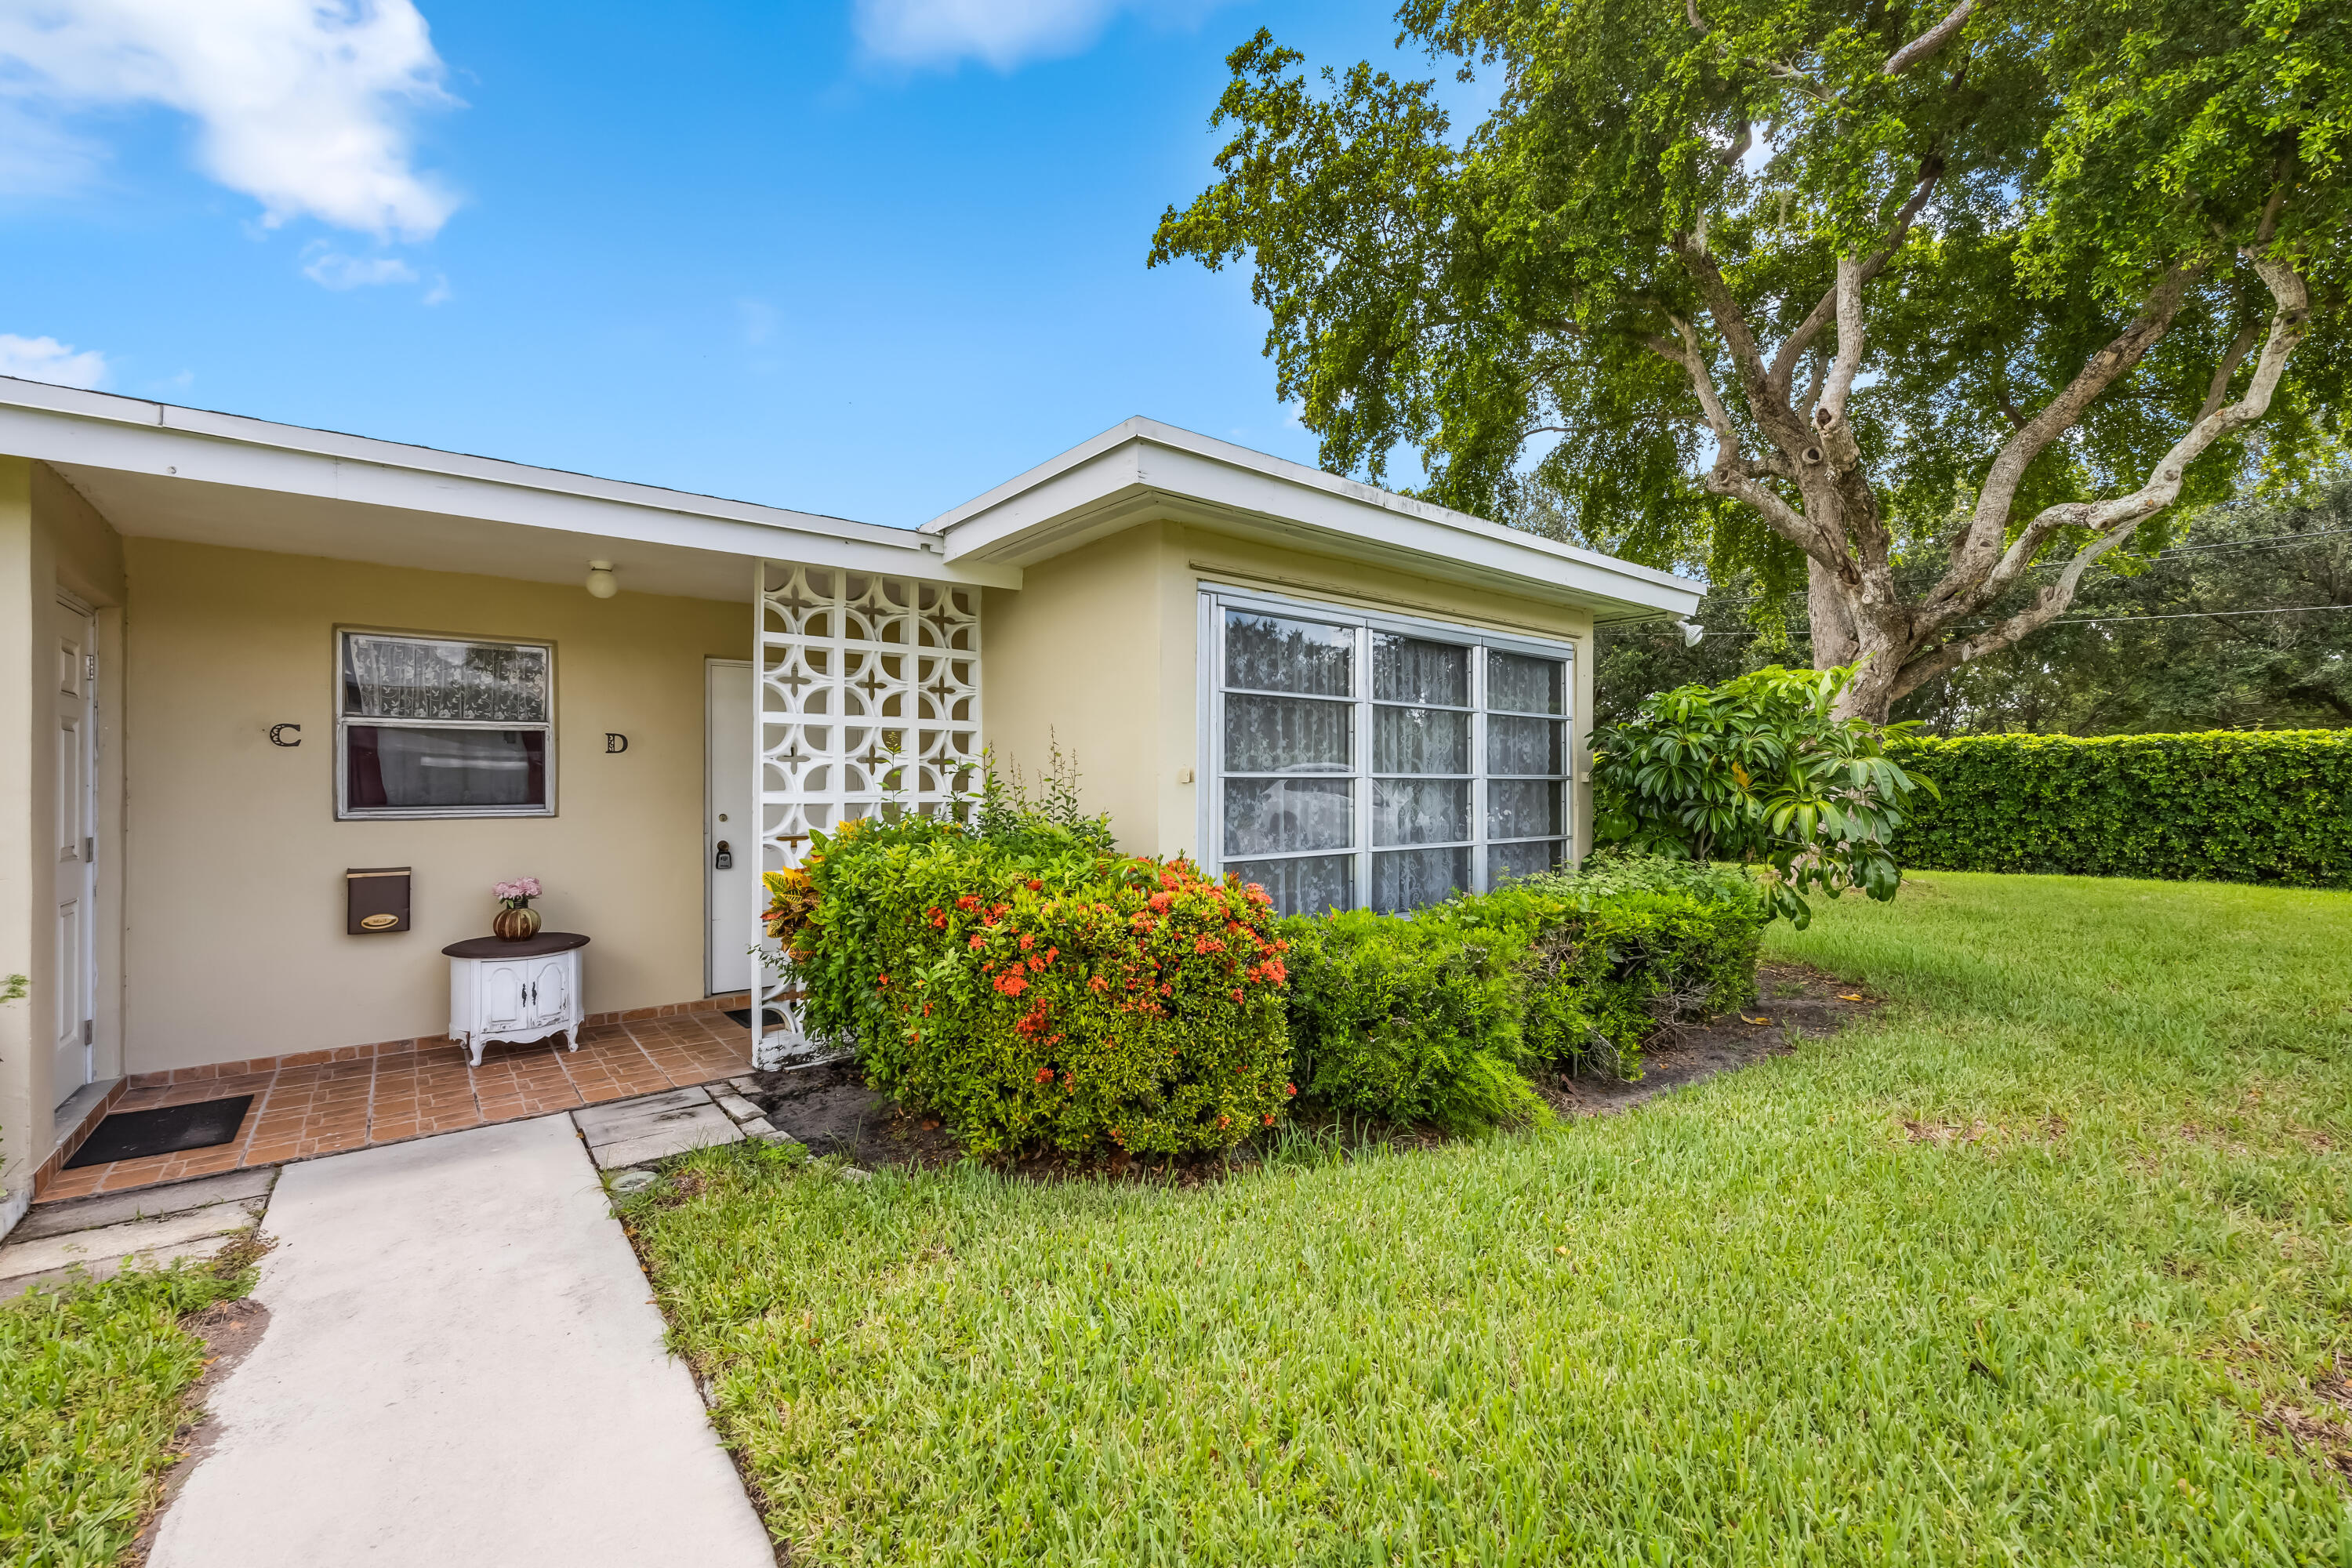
[0,1260,252,1568]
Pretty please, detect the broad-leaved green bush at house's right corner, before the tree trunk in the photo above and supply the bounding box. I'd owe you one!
[1592,666,1933,928]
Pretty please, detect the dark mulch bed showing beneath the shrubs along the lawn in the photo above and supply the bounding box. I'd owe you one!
[748,964,1884,1185]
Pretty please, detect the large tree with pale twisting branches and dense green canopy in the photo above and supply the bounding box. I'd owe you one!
[1152,0,2352,720]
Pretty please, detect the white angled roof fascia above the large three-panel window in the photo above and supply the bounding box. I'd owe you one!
[922,419,1708,616]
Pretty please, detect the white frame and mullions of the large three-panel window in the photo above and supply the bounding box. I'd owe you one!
[1195,581,1576,909]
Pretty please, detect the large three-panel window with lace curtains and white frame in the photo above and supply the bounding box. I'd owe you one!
[1202,593,1571,914]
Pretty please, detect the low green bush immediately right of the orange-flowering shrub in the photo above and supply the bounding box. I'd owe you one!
[1279,909,1543,1128]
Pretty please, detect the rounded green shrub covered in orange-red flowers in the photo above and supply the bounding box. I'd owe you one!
[795,818,1296,1154]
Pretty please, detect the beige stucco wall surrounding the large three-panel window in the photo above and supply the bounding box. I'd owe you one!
[981,520,1592,855]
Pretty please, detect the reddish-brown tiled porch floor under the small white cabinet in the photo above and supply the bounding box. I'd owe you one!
[38,1013,750,1201]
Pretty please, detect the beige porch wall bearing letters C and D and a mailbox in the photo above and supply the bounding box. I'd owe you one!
[125,539,753,1072]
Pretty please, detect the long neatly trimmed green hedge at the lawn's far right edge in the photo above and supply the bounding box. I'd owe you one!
[1889,729,2352,886]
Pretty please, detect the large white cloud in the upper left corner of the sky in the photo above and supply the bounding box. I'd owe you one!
[0,0,456,240]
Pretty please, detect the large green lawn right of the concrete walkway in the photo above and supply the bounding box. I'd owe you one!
[633,874,2352,1566]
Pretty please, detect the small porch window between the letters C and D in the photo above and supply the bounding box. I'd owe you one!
[334,633,555,818]
